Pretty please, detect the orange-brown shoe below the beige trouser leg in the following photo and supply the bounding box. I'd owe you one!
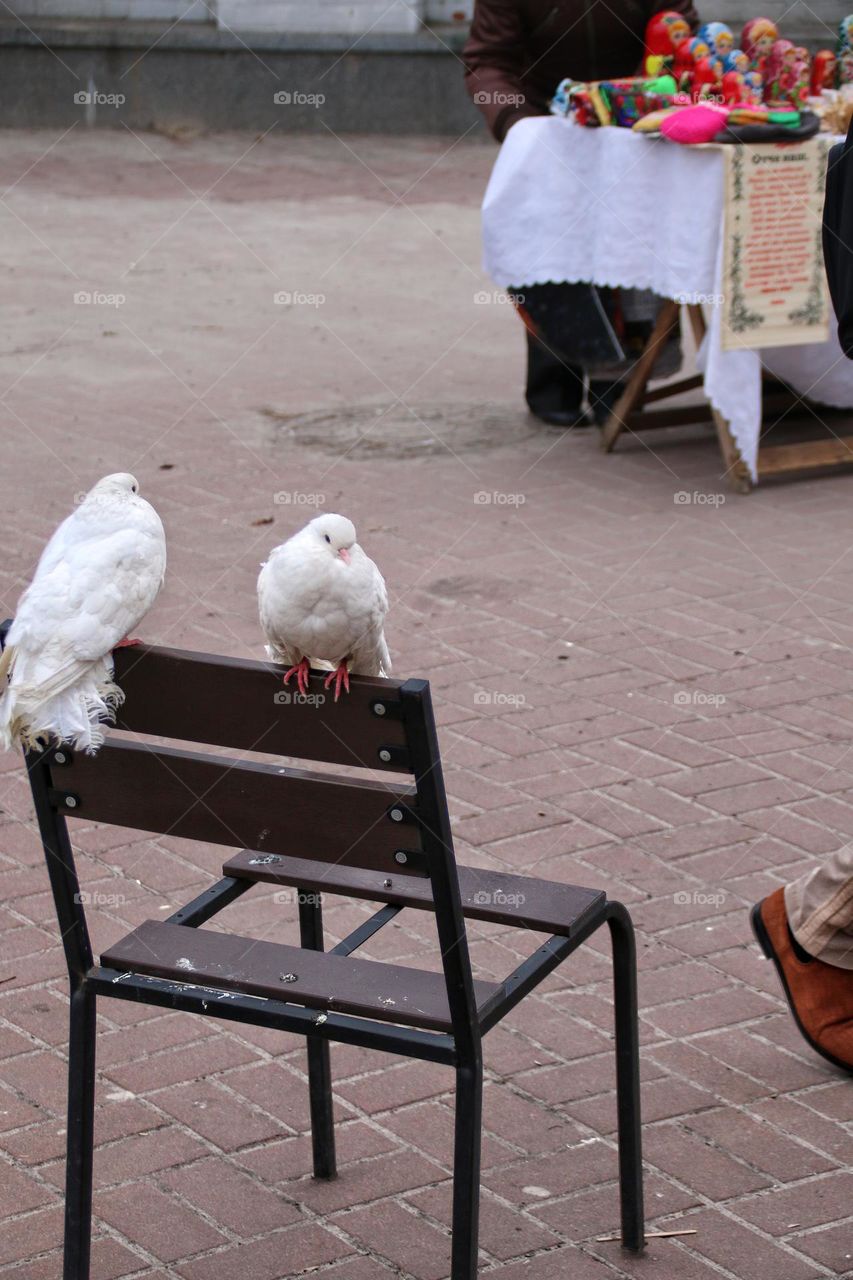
[749,888,853,1073]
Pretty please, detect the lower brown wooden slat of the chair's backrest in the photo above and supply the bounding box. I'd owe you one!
[51,740,420,872]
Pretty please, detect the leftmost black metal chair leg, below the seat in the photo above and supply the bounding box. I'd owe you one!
[63,984,95,1280]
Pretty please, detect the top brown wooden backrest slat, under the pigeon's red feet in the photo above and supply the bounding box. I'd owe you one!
[114,645,406,772]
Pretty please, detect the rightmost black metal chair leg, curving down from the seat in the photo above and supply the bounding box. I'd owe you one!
[607,902,646,1253]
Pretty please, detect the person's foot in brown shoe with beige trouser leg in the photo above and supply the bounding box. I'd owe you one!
[751,846,853,1073]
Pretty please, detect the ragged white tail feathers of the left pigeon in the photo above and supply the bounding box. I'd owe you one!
[0,655,124,753]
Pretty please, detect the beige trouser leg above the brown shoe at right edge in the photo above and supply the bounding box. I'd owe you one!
[785,845,853,970]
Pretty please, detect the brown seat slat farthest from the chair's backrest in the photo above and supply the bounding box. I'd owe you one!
[223,849,607,938]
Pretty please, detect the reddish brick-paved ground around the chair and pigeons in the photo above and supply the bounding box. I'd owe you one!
[0,131,853,1280]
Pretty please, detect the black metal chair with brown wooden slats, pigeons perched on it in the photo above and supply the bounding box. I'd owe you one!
[0,627,644,1280]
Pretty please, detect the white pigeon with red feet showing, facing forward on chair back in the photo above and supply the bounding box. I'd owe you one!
[257,513,391,703]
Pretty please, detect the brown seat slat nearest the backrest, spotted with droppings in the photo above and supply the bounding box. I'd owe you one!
[101,920,501,1032]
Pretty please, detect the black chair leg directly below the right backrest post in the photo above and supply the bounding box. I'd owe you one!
[451,1062,483,1280]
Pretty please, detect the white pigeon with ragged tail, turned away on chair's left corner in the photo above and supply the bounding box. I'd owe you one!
[0,472,167,753]
